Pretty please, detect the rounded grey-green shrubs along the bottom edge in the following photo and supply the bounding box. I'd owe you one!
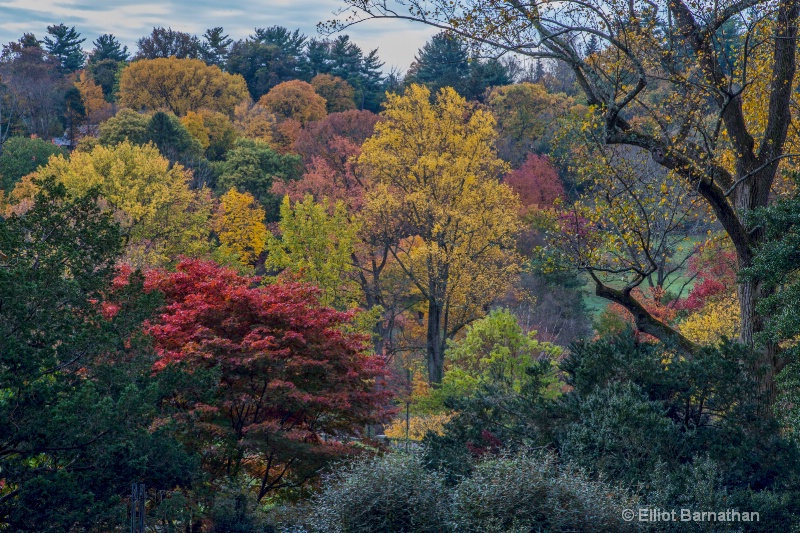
[279,450,636,533]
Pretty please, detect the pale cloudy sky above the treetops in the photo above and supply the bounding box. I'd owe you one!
[0,0,435,70]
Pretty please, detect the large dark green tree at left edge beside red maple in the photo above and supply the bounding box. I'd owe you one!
[0,178,196,532]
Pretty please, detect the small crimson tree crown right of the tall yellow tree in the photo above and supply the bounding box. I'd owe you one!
[503,154,564,211]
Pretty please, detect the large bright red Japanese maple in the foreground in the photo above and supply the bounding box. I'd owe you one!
[146,260,390,500]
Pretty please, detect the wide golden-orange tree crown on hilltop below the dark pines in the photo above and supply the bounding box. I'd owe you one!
[119,57,249,117]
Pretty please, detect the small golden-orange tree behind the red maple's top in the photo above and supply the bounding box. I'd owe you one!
[214,188,268,265]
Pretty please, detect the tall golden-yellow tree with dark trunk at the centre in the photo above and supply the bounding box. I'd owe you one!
[359,85,520,383]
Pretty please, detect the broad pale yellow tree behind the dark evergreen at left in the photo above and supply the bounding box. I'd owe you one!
[14,141,212,267]
